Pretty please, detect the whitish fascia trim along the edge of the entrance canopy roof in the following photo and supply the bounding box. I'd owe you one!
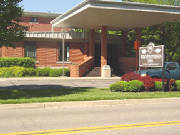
[51,0,180,27]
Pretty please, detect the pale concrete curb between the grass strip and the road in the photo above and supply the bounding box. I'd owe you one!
[0,98,180,110]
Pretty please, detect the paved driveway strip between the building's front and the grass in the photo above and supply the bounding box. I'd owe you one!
[0,77,120,89]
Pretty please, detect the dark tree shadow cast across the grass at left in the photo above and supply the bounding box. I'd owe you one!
[0,85,94,100]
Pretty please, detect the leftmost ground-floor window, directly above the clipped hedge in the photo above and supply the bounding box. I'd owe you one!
[24,42,36,58]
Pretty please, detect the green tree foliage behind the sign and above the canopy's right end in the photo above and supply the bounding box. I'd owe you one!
[123,0,180,62]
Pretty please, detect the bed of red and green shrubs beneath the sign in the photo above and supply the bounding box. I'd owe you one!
[110,72,180,92]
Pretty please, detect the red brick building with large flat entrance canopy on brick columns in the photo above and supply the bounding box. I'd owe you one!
[0,0,180,77]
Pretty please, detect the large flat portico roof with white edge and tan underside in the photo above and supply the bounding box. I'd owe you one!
[51,0,180,29]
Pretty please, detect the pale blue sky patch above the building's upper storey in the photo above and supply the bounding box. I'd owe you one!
[20,0,83,13]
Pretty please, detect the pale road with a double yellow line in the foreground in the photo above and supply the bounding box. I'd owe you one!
[0,98,180,135]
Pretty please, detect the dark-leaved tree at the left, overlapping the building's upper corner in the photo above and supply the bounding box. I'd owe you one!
[0,0,27,47]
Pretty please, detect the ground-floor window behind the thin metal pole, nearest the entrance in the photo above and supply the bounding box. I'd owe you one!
[59,43,69,61]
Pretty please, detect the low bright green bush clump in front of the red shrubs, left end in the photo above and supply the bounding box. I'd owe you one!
[110,80,144,92]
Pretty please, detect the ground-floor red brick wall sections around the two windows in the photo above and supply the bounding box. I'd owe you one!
[0,41,84,67]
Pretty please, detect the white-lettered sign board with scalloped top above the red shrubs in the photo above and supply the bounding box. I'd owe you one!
[139,42,164,67]
